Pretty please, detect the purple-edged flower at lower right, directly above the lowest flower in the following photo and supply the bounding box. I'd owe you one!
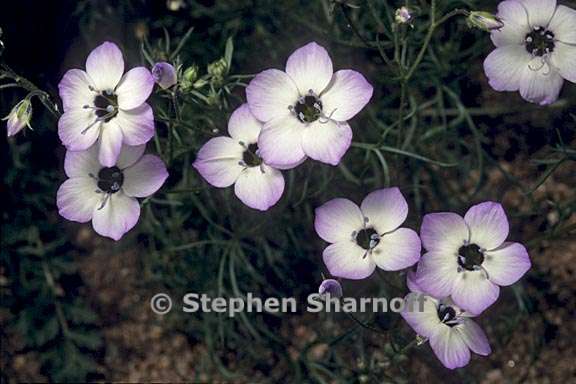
[416,201,530,314]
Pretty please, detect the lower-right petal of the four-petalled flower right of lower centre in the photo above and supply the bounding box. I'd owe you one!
[372,228,421,271]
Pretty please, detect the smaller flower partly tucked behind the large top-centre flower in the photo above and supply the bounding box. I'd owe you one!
[194,104,284,211]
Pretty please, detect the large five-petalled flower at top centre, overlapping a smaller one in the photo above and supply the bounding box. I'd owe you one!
[246,42,373,166]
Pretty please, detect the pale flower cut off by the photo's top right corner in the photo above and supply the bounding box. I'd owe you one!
[484,0,576,105]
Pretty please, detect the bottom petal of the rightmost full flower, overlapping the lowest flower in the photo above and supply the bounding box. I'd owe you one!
[452,271,500,315]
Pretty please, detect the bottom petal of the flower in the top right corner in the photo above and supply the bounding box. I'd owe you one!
[520,62,564,105]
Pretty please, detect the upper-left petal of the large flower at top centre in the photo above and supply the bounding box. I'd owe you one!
[246,69,299,122]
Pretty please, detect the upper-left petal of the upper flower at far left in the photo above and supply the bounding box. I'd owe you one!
[58,69,96,112]
